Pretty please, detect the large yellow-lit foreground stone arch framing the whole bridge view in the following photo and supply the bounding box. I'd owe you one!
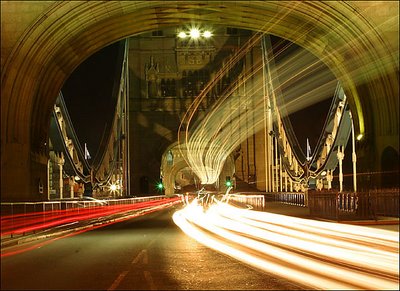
[1,1,399,200]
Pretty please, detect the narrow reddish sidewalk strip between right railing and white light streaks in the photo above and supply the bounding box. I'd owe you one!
[264,202,399,232]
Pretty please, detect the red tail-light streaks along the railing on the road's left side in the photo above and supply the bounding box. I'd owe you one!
[1,195,180,244]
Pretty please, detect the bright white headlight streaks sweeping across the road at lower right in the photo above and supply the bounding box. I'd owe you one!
[173,200,399,290]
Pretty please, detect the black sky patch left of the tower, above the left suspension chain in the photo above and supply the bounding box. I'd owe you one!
[62,43,121,163]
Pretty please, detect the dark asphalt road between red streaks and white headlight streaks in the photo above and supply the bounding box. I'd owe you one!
[1,206,306,290]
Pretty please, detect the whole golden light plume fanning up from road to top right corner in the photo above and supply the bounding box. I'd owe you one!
[178,3,398,189]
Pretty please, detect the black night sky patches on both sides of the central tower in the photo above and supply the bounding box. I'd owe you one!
[62,37,334,167]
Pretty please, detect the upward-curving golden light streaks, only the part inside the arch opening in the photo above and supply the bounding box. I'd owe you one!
[181,30,336,184]
